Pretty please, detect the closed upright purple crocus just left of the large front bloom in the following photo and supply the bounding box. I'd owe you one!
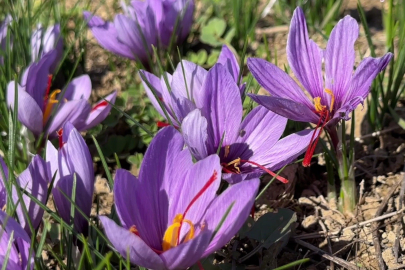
[46,122,94,234]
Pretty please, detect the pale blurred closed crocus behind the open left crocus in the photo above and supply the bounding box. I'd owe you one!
[31,24,63,73]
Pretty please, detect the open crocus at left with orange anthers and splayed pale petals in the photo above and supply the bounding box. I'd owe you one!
[7,50,116,138]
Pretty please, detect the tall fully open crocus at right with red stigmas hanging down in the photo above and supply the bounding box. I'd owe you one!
[248,7,393,166]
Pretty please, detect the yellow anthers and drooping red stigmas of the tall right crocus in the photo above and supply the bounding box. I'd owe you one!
[302,89,335,167]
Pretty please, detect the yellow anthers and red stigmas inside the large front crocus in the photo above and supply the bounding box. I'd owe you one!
[129,171,218,254]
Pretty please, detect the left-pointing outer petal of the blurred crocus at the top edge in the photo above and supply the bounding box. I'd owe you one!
[83,11,135,60]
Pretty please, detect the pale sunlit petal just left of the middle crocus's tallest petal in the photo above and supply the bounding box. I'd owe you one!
[171,60,208,108]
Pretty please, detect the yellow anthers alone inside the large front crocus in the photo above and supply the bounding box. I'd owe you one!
[162,214,195,251]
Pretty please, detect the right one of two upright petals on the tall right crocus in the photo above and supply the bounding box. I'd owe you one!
[325,16,359,108]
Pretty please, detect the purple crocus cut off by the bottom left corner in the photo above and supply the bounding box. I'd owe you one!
[0,211,34,270]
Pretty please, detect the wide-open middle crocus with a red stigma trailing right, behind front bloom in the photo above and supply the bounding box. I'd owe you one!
[181,64,313,184]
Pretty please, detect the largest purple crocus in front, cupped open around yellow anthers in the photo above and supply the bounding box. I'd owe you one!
[99,127,260,269]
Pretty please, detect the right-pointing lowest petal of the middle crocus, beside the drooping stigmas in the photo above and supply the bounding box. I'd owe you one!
[251,129,319,171]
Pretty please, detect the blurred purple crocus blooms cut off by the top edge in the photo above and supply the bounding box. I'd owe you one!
[84,0,194,64]
